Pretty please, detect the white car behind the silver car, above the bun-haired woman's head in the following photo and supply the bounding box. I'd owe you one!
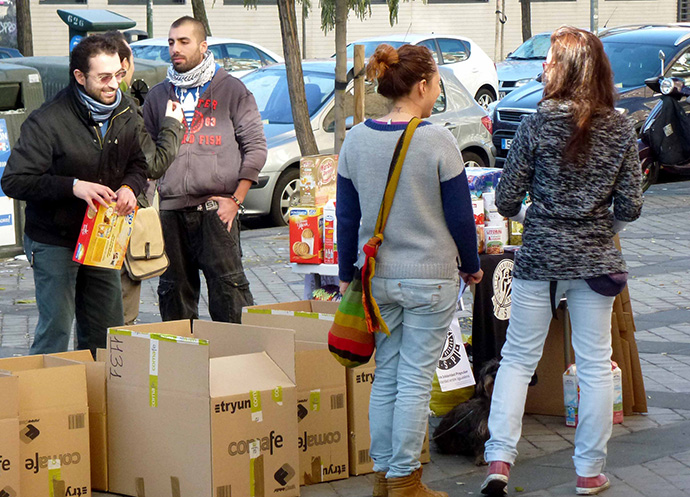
[347,34,498,109]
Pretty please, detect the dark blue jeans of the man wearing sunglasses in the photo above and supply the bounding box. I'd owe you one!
[24,235,124,356]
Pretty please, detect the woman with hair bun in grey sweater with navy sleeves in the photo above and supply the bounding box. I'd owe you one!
[336,45,482,497]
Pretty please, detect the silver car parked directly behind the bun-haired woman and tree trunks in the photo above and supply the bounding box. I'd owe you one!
[242,59,495,225]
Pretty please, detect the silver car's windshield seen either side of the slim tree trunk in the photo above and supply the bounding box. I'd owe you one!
[242,67,335,124]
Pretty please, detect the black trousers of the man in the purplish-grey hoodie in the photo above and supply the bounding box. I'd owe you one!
[158,210,254,323]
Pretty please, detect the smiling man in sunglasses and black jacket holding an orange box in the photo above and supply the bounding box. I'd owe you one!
[2,35,146,354]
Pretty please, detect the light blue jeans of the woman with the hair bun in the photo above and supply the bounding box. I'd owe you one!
[369,277,459,478]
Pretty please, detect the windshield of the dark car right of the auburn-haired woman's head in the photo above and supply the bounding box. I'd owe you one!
[602,38,678,90]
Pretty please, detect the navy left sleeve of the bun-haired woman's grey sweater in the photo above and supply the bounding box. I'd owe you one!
[335,174,362,281]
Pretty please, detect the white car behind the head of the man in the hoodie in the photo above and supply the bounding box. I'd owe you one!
[131,36,283,78]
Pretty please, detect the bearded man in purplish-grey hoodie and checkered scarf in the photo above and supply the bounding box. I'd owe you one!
[144,16,267,323]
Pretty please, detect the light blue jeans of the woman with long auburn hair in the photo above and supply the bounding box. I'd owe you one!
[485,278,614,477]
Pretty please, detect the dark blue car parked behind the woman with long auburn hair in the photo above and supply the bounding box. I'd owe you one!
[492,24,690,166]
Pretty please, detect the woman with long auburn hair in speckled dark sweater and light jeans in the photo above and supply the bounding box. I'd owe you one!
[481,26,642,495]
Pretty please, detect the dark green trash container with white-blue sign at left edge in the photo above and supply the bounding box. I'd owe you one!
[0,64,44,257]
